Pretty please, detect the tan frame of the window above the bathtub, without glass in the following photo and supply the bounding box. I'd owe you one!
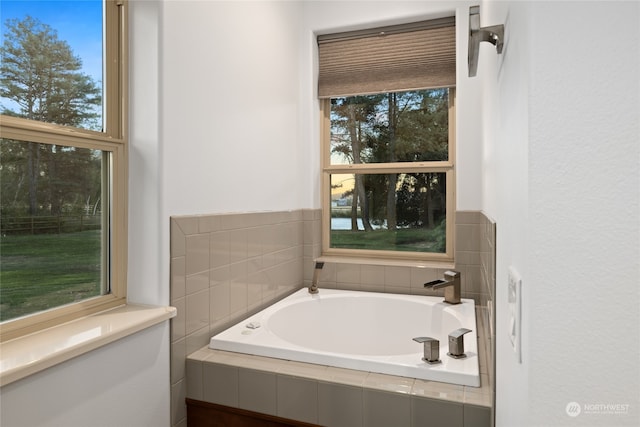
[319,87,456,263]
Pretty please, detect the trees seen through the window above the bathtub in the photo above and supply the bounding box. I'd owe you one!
[331,89,449,231]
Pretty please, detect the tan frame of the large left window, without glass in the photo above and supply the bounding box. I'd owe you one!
[0,0,128,342]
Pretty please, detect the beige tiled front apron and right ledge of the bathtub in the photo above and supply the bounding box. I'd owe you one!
[186,306,492,427]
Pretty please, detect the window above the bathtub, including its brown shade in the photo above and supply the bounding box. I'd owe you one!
[318,18,455,261]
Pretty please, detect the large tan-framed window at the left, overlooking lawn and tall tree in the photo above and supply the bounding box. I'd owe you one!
[0,0,127,341]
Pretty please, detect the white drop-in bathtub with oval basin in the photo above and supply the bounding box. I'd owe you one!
[209,288,480,387]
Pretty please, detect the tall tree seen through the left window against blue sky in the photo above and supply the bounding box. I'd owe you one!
[0,16,102,215]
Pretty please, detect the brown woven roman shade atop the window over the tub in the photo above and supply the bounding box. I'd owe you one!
[318,17,456,98]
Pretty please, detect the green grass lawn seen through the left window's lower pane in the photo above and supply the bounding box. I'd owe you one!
[0,230,101,321]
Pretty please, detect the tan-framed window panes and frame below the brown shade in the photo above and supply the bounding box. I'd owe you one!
[323,88,455,261]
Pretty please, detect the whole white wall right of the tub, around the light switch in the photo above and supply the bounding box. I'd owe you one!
[478,2,640,426]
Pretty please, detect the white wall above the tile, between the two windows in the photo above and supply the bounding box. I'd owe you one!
[160,1,308,215]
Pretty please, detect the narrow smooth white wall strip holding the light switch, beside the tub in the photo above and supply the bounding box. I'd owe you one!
[475,2,533,427]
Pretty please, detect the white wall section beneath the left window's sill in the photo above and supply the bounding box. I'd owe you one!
[0,322,169,427]
